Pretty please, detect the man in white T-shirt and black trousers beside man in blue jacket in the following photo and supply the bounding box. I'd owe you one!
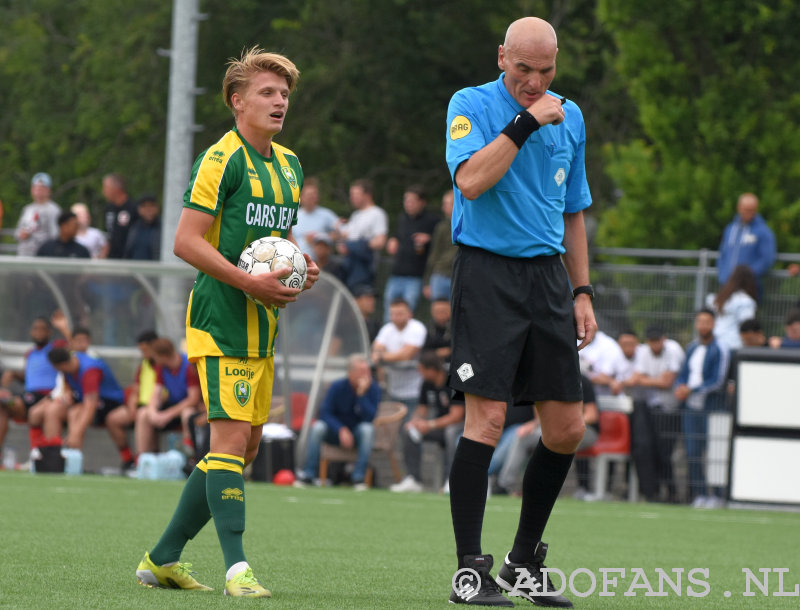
[623,326,684,502]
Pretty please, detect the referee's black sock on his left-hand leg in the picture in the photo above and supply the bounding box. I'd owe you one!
[450,436,494,568]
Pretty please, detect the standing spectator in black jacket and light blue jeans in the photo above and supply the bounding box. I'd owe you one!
[383,185,438,323]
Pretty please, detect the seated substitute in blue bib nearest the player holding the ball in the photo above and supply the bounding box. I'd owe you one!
[134,337,202,455]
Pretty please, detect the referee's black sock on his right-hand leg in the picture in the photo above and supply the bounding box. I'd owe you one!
[508,439,575,563]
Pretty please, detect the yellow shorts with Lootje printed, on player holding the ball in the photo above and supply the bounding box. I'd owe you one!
[196,356,275,426]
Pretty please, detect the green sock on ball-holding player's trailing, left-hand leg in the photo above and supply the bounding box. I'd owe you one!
[150,458,211,566]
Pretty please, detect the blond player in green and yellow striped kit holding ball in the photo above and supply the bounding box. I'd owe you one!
[136,47,319,597]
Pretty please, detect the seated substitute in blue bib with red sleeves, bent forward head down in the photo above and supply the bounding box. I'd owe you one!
[30,347,133,465]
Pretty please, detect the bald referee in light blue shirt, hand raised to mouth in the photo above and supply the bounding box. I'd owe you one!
[447,17,597,607]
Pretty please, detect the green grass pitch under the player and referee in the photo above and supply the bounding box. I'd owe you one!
[0,472,800,609]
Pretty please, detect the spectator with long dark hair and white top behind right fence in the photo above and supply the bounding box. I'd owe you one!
[706,265,758,350]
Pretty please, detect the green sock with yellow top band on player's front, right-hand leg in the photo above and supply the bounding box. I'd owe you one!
[206,453,246,570]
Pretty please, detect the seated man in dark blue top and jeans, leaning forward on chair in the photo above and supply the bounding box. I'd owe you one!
[299,355,381,491]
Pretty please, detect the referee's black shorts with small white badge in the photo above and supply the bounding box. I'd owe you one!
[448,245,583,405]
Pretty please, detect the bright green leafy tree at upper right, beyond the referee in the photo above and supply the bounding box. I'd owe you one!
[598,0,800,251]
